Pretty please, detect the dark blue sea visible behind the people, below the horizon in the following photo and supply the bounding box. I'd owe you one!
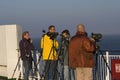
[33,35,120,54]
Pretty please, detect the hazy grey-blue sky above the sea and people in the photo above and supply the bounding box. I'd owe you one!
[0,0,120,38]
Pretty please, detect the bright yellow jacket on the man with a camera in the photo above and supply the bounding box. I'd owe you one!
[41,35,58,60]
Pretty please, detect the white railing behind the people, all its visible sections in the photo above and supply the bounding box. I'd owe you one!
[11,51,120,80]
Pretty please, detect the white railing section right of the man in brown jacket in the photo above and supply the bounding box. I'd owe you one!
[93,51,120,80]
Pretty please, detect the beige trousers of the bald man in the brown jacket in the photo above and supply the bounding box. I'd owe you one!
[76,67,93,80]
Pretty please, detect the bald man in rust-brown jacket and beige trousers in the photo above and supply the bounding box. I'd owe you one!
[69,24,95,80]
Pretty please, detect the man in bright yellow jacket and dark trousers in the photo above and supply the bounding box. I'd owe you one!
[41,25,58,80]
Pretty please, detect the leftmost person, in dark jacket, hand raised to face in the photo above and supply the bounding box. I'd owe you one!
[19,31,34,80]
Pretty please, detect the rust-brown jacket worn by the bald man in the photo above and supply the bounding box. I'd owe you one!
[69,32,95,68]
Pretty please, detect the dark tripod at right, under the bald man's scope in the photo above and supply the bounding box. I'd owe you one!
[95,42,112,80]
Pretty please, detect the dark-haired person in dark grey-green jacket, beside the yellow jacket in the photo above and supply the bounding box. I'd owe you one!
[59,29,74,80]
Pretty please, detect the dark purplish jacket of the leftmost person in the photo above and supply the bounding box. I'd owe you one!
[19,39,34,60]
